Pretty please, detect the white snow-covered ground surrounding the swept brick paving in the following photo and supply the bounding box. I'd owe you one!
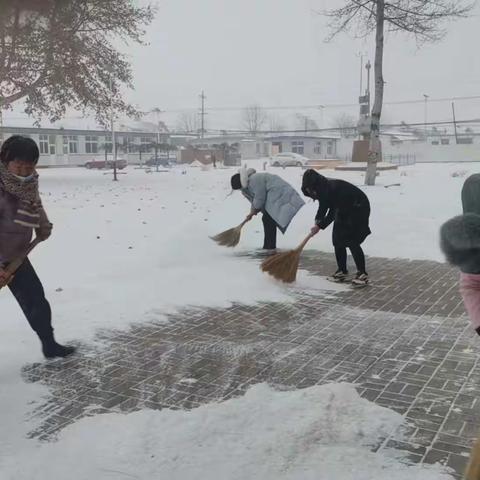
[0,162,472,480]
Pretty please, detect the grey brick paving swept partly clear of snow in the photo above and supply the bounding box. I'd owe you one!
[23,252,480,478]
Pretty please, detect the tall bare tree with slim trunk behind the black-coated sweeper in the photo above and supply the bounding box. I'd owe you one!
[326,0,475,185]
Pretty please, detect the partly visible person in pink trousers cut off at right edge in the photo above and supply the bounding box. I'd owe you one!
[440,174,480,335]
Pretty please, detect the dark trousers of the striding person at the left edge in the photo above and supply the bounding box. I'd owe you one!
[8,259,53,341]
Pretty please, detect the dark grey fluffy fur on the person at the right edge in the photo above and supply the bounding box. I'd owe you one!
[440,213,480,273]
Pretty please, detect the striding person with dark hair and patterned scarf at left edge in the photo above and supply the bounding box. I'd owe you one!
[0,136,75,358]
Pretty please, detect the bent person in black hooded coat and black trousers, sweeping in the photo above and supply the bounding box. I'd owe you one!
[302,170,371,285]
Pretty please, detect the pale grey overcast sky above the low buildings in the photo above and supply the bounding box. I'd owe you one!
[6,0,480,129]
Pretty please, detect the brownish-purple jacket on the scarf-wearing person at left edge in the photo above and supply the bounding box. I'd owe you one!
[0,183,51,267]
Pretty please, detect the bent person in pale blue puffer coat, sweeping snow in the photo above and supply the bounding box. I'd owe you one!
[230,167,305,250]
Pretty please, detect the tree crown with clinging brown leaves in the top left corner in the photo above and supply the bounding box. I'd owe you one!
[0,0,155,125]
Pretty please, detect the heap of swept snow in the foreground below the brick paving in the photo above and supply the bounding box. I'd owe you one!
[2,384,453,480]
